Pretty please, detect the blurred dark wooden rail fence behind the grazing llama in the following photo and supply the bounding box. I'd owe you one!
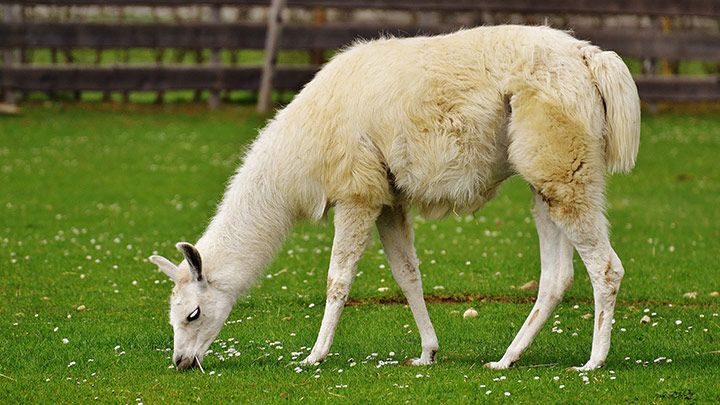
[0,0,720,106]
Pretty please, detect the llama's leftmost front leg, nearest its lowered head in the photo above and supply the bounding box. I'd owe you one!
[301,204,380,365]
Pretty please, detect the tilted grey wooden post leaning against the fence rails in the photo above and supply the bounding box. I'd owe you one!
[258,0,285,112]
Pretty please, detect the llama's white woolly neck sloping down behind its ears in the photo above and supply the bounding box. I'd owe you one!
[198,145,295,299]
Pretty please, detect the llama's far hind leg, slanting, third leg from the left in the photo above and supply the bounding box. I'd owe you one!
[485,192,573,369]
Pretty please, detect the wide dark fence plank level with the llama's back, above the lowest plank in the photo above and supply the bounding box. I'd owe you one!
[0,23,720,60]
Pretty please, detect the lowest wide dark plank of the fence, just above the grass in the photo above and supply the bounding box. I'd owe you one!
[0,65,720,101]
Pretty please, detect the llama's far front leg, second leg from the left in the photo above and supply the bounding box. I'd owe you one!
[377,206,438,365]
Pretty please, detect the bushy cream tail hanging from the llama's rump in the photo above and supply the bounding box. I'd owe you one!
[583,47,640,173]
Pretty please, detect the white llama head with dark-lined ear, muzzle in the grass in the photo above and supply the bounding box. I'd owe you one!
[150,242,233,370]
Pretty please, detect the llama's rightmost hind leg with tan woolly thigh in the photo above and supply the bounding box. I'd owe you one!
[508,92,624,369]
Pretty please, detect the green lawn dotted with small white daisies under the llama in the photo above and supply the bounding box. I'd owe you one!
[0,103,720,403]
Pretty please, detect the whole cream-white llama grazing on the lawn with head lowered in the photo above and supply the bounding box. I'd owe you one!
[150,26,640,370]
